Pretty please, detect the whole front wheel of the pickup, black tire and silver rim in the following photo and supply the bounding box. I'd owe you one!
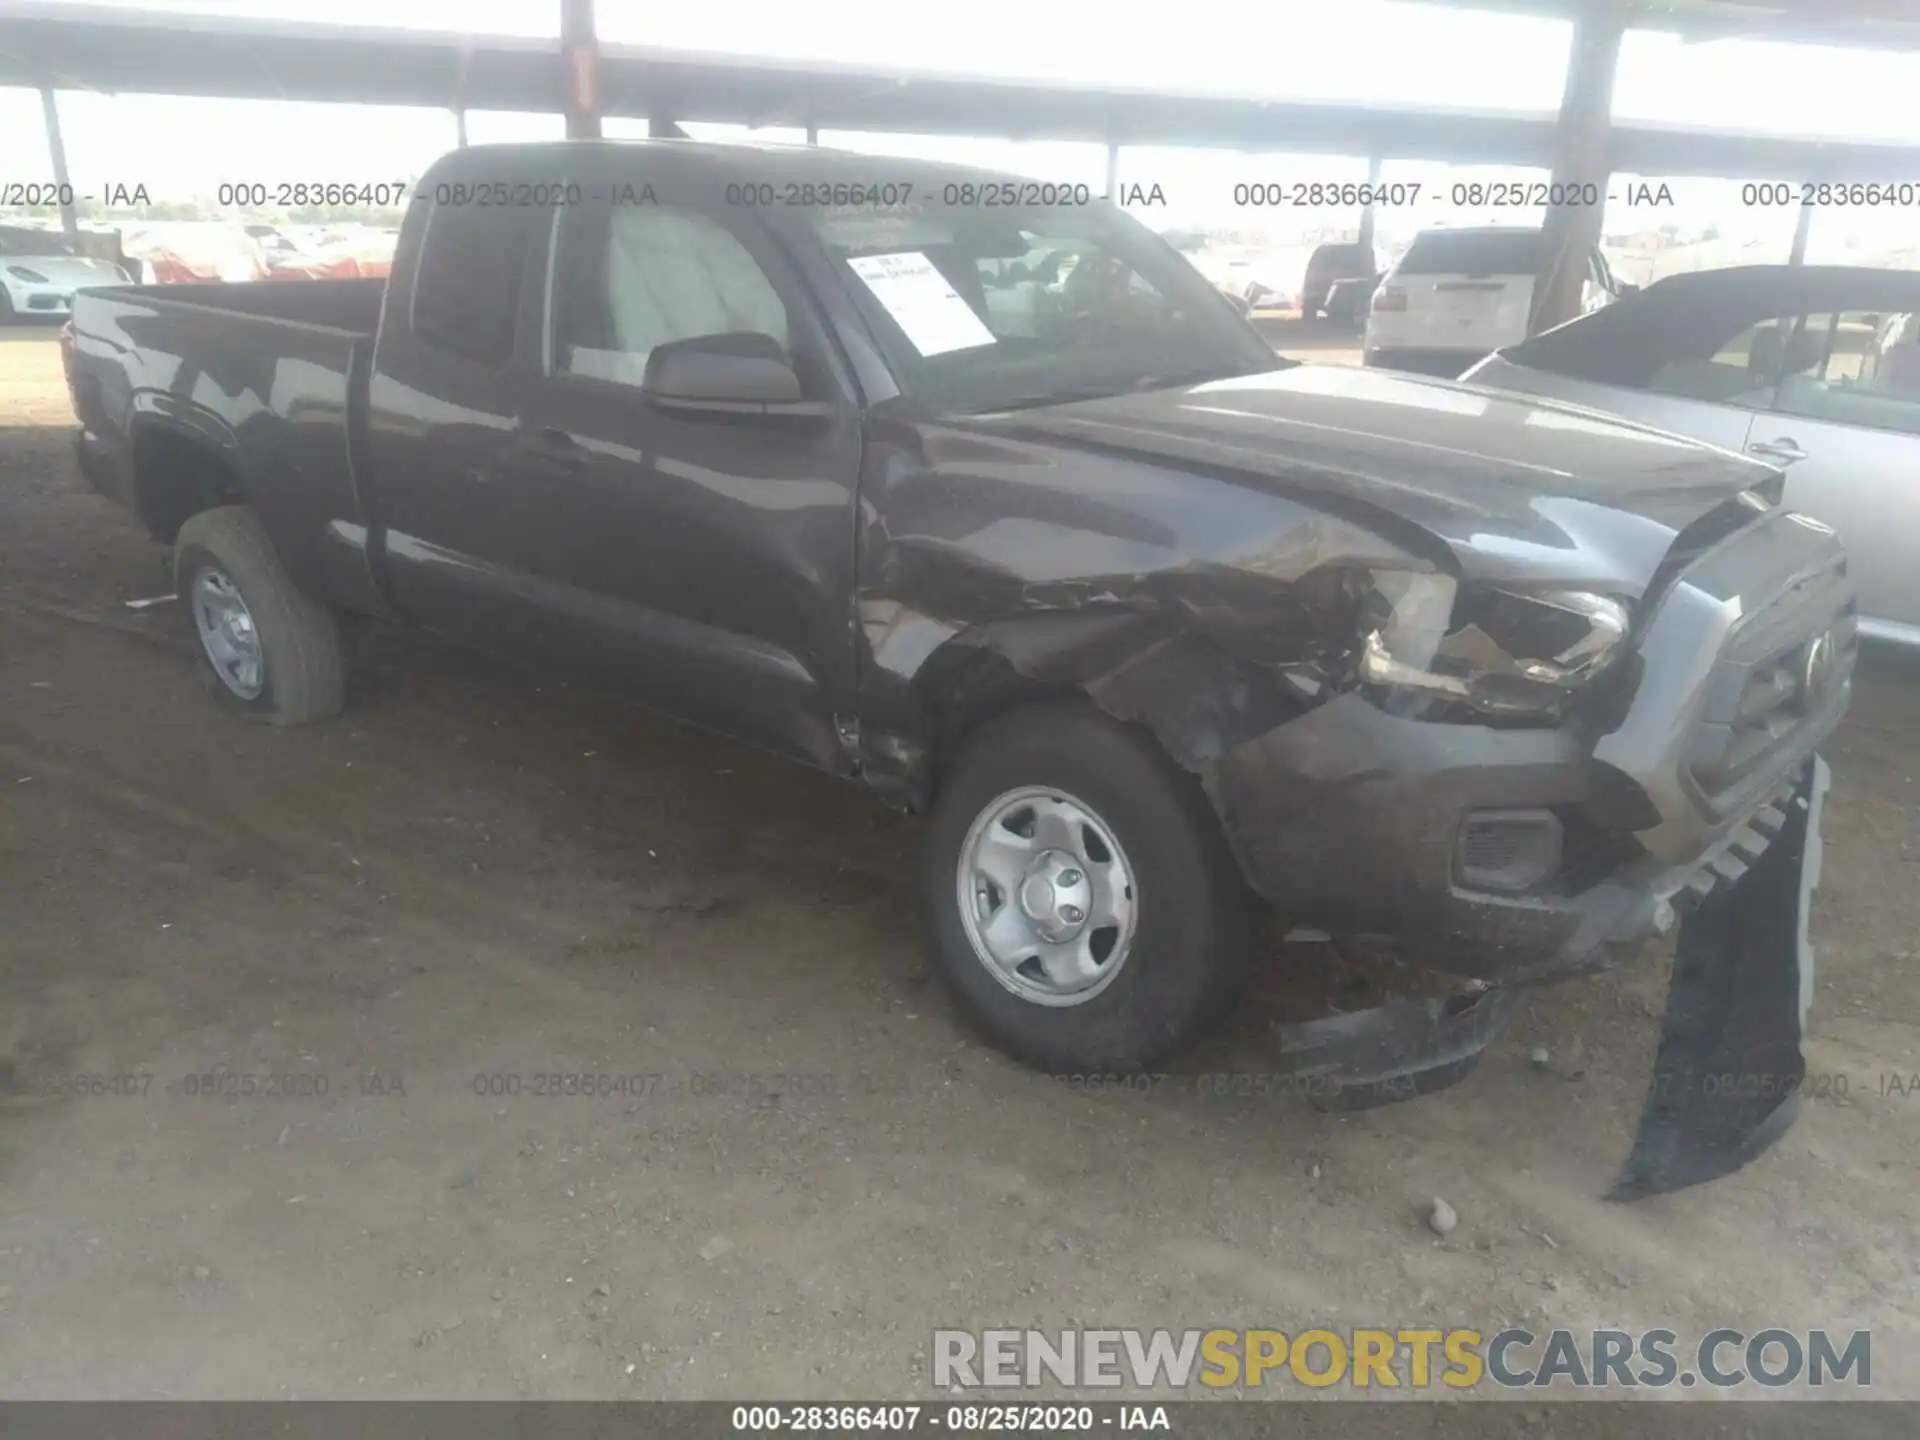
[916,703,1252,1073]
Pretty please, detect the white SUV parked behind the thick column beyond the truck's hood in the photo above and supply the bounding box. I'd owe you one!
[1361,225,1634,378]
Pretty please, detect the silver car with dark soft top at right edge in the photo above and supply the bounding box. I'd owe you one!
[1461,265,1920,645]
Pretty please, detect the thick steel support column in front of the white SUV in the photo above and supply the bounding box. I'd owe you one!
[1526,0,1626,334]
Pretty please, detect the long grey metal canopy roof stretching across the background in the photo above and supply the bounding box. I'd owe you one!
[0,0,1920,180]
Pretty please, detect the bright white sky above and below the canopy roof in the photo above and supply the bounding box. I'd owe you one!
[0,0,1920,246]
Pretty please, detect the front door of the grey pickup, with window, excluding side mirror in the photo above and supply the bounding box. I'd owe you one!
[497,192,860,772]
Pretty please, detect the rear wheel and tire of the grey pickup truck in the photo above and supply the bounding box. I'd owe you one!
[173,505,346,726]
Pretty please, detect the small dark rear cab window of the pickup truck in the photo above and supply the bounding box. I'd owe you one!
[413,204,536,365]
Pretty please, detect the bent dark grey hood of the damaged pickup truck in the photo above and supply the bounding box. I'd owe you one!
[979,365,1772,597]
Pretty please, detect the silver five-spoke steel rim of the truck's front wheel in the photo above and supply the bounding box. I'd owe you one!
[954,787,1139,1006]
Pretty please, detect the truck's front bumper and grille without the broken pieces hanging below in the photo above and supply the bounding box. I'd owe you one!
[1208,511,1855,983]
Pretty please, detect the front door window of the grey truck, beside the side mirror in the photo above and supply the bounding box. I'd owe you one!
[551,205,789,386]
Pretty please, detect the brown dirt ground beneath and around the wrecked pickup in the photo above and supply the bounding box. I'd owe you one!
[0,320,1920,1398]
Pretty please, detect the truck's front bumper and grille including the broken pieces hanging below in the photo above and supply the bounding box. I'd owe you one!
[1210,511,1857,1200]
